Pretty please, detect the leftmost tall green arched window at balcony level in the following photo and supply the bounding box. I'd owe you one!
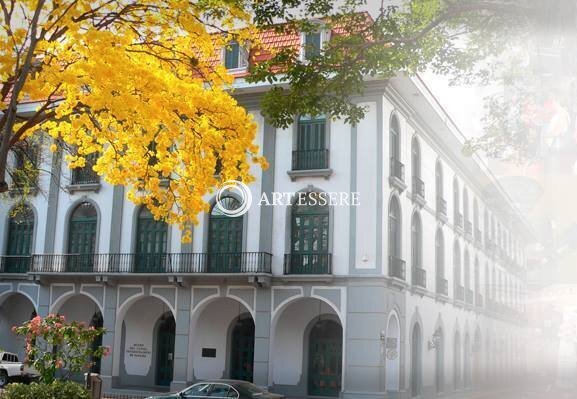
[0,205,34,273]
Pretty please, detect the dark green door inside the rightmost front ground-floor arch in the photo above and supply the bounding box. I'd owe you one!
[308,320,343,396]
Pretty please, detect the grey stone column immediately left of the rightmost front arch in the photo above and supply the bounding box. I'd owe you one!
[253,287,271,386]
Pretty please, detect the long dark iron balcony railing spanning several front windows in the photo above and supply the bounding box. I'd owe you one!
[30,252,272,273]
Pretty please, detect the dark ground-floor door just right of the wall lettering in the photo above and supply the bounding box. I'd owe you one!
[156,313,176,386]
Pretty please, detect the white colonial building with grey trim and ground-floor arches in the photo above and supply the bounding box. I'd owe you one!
[0,28,530,398]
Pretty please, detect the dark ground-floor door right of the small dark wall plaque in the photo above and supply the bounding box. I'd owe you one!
[230,317,254,382]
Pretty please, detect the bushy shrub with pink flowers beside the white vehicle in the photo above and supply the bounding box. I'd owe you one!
[12,314,108,384]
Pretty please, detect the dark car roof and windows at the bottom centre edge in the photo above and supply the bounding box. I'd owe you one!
[146,380,284,399]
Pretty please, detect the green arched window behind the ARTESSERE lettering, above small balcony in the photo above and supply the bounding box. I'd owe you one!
[285,192,331,274]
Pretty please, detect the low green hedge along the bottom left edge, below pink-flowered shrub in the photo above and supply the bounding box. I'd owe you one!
[2,380,90,399]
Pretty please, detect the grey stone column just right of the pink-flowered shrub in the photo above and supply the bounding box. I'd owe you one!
[100,286,117,391]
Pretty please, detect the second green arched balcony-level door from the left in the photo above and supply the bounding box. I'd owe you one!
[66,202,98,272]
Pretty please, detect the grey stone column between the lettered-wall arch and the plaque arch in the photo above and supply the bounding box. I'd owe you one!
[170,287,191,391]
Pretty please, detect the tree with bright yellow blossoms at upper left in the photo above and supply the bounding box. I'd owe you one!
[0,0,266,239]
